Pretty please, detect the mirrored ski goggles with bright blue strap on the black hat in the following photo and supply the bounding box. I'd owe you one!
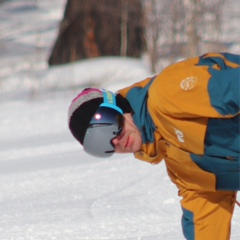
[83,90,124,157]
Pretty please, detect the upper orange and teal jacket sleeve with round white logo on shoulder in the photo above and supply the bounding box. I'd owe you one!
[149,54,240,118]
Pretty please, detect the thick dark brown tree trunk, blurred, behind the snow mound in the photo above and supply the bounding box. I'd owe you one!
[48,0,145,65]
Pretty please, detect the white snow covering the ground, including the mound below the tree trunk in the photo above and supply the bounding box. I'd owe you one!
[0,0,240,240]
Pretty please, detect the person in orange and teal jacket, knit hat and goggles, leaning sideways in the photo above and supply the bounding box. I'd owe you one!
[68,53,240,240]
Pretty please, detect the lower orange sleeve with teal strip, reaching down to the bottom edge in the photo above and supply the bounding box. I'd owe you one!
[179,189,236,240]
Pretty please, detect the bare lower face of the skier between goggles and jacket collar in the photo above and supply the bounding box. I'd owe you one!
[112,113,142,153]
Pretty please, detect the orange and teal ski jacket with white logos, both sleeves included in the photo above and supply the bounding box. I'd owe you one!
[119,53,240,240]
